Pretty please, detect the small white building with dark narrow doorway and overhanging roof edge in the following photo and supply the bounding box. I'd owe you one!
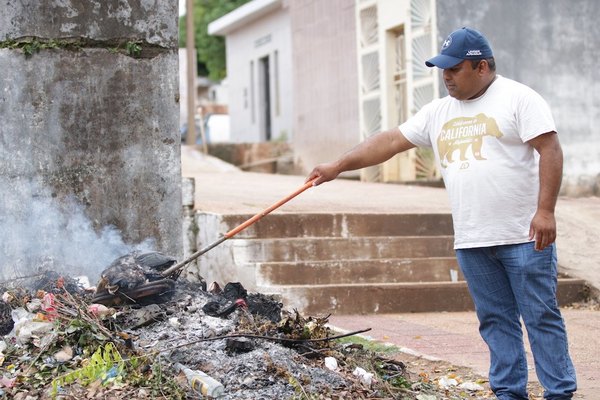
[209,0,293,142]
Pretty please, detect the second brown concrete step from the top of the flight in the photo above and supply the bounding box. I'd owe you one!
[230,236,454,264]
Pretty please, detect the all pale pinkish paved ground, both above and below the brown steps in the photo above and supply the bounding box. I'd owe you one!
[182,149,600,400]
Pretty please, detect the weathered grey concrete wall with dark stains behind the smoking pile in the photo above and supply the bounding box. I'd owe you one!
[0,0,182,279]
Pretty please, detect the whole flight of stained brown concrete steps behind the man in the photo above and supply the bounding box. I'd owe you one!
[197,213,586,314]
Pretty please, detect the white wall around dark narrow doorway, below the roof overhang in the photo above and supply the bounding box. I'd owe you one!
[226,2,293,143]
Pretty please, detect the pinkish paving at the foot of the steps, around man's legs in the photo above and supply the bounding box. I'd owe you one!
[329,308,600,400]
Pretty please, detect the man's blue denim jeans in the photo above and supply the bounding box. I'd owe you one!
[456,242,577,400]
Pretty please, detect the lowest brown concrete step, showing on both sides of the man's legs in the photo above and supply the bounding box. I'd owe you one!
[277,278,588,315]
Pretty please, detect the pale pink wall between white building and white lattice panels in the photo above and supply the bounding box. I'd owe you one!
[289,0,360,172]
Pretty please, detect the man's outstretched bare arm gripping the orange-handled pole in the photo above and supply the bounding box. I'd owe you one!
[306,128,415,186]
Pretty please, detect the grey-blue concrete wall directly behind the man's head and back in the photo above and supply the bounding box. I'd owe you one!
[437,0,600,195]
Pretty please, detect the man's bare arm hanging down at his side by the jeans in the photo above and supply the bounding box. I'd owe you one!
[528,132,563,251]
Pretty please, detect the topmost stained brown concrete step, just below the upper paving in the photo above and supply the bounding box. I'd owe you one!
[196,213,454,239]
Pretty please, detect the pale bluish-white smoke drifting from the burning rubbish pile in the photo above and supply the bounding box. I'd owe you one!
[0,178,155,283]
